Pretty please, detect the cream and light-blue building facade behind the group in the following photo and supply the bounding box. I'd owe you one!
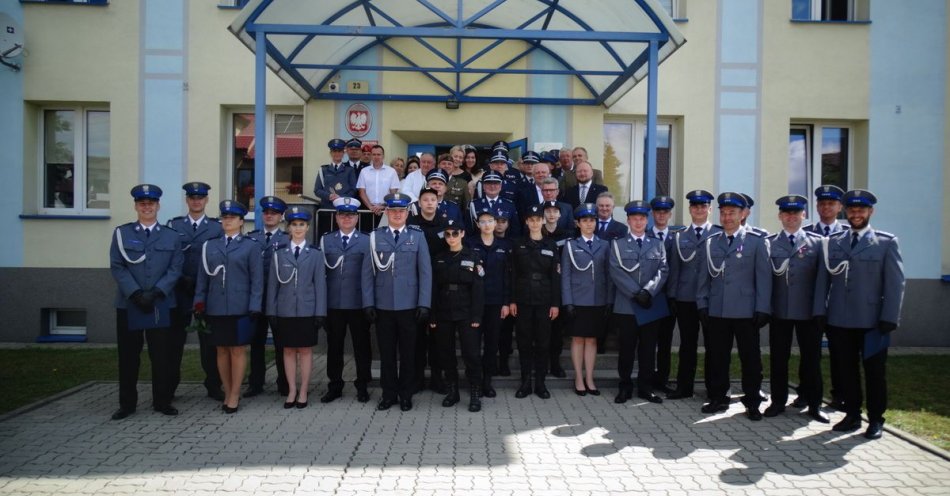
[0,0,950,346]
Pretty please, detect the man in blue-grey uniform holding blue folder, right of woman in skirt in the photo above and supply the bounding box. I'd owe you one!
[608,200,669,403]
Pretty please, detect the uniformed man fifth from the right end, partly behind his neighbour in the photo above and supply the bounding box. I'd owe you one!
[666,189,722,400]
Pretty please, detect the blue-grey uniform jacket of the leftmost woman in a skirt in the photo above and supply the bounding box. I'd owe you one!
[194,235,264,315]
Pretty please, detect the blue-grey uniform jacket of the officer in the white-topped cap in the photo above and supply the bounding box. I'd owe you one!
[320,229,375,310]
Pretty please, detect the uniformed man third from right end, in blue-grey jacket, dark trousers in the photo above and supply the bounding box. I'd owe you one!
[765,195,829,424]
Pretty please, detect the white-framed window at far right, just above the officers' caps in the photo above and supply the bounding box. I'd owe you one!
[788,124,853,215]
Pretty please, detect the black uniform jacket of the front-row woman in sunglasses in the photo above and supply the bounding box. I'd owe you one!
[432,247,485,323]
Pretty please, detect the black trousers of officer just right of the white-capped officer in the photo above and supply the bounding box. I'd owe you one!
[376,309,418,401]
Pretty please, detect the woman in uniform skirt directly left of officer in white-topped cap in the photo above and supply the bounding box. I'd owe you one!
[265,207,327,408]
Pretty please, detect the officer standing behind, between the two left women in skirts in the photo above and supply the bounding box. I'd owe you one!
[244,196,290,398]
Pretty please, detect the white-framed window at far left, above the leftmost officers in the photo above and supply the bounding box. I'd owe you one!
[38,107,111,214]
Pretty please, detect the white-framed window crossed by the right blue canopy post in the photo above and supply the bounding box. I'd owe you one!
[603,120,673,207]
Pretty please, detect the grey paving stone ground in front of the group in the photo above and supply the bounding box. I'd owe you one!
[0,355,950,496]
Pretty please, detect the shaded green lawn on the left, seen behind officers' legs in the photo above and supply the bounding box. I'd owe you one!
[0,346,274,413]
